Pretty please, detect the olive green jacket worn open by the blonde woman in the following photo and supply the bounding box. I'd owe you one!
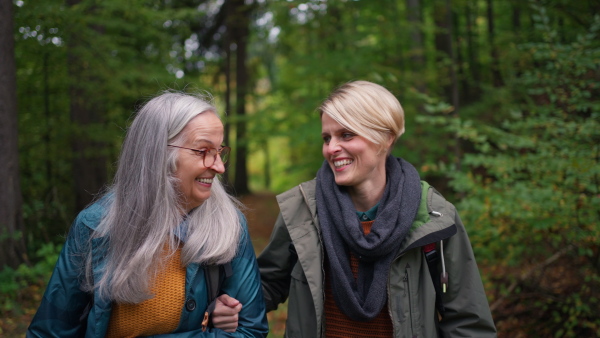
[258,180,496,338]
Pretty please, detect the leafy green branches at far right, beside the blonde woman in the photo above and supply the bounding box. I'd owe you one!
[454,12,600,264]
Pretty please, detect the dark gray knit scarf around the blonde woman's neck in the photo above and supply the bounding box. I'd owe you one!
[317,156,421,321]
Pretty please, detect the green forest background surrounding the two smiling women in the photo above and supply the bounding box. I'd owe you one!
[0,0,600,337]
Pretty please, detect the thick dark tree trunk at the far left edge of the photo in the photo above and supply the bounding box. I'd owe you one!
[0,0,27,269]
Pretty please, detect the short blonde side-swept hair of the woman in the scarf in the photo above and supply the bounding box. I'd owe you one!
[319,81,404,146]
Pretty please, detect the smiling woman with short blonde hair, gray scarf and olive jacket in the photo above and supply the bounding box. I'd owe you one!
[215,81,496,338]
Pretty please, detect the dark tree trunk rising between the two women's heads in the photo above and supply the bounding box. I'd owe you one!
[231,0,250,195]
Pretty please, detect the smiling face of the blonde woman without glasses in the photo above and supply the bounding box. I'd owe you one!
[321,113,393,195]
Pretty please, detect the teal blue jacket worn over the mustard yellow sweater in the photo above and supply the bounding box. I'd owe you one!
[27,198,268,338]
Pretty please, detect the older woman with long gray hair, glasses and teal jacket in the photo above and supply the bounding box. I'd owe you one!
[27,92,268,337]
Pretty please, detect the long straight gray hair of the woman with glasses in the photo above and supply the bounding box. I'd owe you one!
[86,92,241,303]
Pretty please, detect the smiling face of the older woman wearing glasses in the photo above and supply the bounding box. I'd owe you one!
[174,111,225,212]
